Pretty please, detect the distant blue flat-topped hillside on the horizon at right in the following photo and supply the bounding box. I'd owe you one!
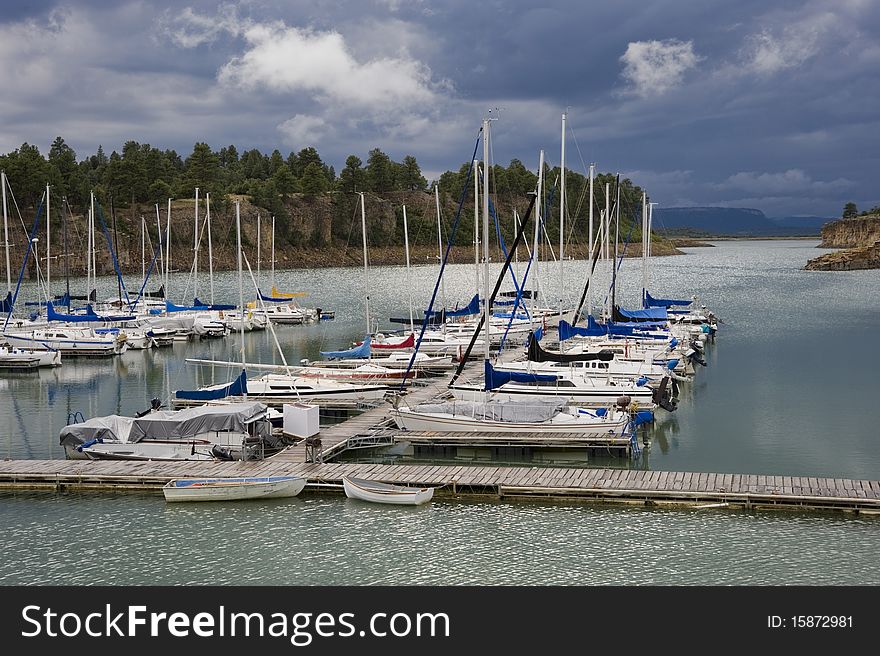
[653,207,832,237]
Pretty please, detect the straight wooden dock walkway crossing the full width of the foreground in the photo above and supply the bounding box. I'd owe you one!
[0,456,880,514]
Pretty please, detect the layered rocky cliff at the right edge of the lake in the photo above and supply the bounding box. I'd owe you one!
[804,215,880,271]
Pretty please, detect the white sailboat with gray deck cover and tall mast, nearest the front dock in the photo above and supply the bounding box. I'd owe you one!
[391,119,632,436]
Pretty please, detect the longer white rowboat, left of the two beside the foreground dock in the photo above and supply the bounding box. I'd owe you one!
[162,476,306,501]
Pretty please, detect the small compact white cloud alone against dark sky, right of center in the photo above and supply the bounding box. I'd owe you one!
[620,39,702,96]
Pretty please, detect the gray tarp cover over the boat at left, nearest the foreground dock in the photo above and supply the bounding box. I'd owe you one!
[61,401,267,446]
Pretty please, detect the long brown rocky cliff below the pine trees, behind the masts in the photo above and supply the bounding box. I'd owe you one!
[1,191,680,281]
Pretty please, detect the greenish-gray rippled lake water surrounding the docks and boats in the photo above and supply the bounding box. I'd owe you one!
[0,240,880,585]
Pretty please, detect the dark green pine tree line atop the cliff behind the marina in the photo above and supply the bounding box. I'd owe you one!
[0,136,642,254]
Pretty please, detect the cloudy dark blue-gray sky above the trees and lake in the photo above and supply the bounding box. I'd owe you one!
[0,0,880,218]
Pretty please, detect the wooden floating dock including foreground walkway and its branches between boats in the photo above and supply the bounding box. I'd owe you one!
[0,354,880,514]
